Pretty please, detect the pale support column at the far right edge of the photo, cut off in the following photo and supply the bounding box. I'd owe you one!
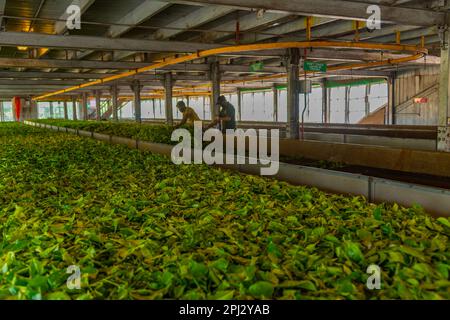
[437,26,450,152]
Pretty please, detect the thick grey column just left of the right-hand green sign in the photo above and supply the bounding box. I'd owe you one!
[286,49,300,139]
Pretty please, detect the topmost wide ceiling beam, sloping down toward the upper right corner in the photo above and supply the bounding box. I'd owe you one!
[161,0,446,26]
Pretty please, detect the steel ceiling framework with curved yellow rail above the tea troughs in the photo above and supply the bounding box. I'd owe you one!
[0,0,450,150]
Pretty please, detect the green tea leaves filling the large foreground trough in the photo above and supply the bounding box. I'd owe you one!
[0,124,450,299]
